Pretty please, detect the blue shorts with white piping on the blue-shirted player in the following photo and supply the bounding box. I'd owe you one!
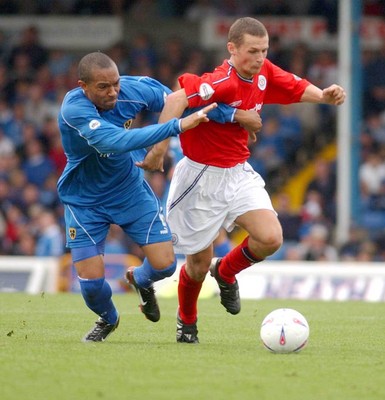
[64,181,171,249]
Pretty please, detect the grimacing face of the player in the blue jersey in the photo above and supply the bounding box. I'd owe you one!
[79,66,120,111]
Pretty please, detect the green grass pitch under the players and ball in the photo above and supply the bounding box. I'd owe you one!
[0,293,385,400]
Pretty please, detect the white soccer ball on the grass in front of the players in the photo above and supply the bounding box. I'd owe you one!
[260,308,309,353]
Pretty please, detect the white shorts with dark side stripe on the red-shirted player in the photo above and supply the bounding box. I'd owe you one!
[167,157,274,255]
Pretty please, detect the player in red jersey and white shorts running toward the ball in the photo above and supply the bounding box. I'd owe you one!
[141,17,346,343]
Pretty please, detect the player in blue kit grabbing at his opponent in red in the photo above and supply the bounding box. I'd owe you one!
[58,52,220,342]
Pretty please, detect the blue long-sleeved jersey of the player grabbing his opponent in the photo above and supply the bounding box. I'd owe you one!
[58,76,180,207]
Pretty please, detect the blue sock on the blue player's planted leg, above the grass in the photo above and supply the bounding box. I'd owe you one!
[79,278,118,324]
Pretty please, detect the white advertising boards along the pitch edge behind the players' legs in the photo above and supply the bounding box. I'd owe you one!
[0,257,385,302]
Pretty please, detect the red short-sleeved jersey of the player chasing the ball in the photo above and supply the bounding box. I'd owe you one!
[179,59,310,168]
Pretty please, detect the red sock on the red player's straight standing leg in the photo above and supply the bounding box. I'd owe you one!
[178,265,203,324]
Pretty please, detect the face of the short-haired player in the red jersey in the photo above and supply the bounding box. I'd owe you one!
[228,34,269,79]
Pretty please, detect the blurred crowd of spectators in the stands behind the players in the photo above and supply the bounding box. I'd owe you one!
[0,0,385,261]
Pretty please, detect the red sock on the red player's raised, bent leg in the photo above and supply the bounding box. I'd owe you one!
[219,236,263,283]
